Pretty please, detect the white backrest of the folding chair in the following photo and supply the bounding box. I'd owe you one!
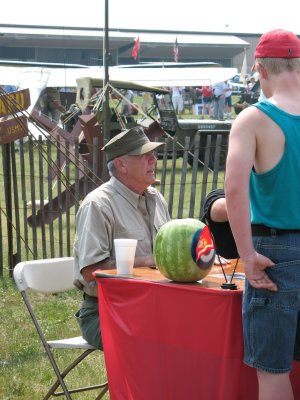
[13,257,75,293]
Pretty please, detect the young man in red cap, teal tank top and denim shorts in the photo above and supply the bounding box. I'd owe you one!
[225,30,300,400]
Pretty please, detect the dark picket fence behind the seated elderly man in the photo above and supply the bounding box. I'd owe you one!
[0,135,227,277]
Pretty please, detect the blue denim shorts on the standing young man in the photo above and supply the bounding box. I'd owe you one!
[243,233,300,374]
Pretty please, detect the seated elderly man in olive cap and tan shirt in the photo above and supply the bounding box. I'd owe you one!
[74,127,170,348]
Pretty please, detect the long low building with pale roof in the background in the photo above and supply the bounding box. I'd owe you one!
[0,25,260,74]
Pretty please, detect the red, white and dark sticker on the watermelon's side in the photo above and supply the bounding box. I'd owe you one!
[195,226,216,269]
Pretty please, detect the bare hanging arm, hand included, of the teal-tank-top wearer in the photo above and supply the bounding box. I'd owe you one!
[225,107,277,290]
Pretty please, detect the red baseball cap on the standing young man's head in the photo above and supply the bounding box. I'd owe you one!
[254,29,300,58]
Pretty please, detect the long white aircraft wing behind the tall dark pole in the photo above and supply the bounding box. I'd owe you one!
[0,66,237,88]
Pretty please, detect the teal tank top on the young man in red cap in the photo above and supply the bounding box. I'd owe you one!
[250,100,300,229]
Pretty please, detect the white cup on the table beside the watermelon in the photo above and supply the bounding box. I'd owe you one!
[114,239,137,275]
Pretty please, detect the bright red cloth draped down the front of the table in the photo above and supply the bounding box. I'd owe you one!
[97,277,300,400]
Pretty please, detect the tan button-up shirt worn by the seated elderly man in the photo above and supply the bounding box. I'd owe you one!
[74,177,170,296]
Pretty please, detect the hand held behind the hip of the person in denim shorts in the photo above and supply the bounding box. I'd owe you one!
[242,253,278,292]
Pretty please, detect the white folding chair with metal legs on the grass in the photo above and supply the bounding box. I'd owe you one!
[14,257,108,400]
